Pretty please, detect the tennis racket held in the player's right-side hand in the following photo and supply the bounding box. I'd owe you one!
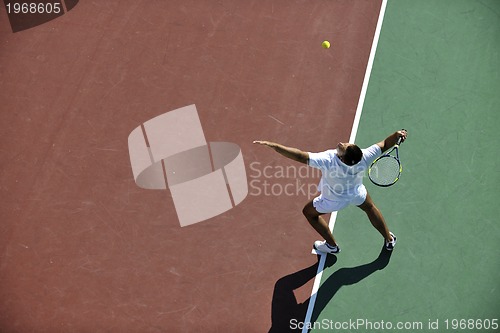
[368,137,403,187]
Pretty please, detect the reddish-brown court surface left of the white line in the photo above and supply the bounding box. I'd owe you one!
[0,0,381,333]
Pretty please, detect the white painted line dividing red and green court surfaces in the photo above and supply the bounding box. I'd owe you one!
[302,0,387,333]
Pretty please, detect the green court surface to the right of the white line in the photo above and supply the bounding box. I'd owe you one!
[311,0,500,332]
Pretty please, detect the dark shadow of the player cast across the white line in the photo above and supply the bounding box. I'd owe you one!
[269,248,392,333]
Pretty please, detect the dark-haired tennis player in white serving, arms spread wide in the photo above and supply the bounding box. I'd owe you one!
[254,130,408,254]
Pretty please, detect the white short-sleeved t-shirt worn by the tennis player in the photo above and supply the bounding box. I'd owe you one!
[309,144,382,200]
